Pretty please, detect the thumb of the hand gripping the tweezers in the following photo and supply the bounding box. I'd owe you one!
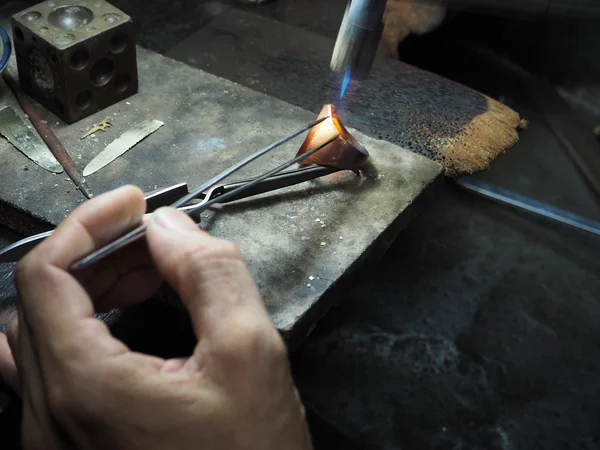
[147,208,272,342]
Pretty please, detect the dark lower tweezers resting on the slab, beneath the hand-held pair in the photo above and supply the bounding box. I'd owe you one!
[0,166,340,263]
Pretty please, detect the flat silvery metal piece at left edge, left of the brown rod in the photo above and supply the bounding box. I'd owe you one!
[0,106,63,173]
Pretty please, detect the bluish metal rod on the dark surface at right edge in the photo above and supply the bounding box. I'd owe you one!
[456,178,600,237]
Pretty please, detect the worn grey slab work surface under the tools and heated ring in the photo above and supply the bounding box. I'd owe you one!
[0,45,442,335]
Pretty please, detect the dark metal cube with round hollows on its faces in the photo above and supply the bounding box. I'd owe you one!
[12,0,138,123]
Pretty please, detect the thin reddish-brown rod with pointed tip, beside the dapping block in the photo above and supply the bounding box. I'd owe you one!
[3,71,93,198]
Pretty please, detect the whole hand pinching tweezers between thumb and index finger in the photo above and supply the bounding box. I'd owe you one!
[0,187,311,450]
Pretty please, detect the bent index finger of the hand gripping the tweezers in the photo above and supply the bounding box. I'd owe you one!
[16,186,145,358]
